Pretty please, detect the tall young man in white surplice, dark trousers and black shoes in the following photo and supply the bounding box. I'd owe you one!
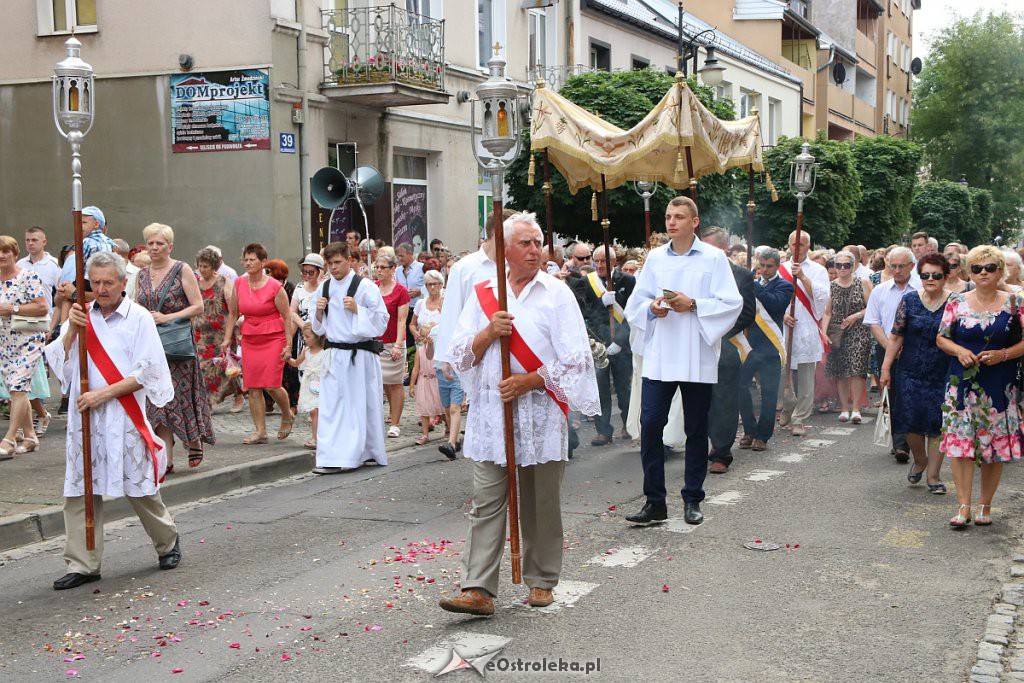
[626,197,743,524]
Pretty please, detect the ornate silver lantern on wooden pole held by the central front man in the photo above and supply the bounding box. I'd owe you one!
[471,43,525,584]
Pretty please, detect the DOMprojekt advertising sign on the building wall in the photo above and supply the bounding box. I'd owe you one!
[171,69,270,153]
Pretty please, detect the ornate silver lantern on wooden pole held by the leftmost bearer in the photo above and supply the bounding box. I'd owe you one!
[53,36,96,550]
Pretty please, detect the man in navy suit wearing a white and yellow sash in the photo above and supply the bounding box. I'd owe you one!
[739,247,793,451]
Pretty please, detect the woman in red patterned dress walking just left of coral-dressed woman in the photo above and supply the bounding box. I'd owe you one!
[195,248,242,412]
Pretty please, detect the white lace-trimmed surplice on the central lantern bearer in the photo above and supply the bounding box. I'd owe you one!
[447,271,601,466]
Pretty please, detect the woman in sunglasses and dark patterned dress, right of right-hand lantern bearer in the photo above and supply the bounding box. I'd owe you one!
[821,251,871,425]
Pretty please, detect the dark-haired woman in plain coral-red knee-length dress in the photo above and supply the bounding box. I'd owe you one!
[221,243,295,444]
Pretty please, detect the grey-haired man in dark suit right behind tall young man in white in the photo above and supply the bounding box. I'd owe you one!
[700,225,757,474]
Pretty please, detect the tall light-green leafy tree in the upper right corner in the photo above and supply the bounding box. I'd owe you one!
[910,12,1024,237]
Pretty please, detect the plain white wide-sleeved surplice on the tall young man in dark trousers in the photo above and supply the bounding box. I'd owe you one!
[626,238,743,384]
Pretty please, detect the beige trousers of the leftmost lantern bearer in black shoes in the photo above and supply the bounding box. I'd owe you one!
[65,492,178,574]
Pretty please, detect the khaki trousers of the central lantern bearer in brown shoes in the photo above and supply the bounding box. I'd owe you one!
[462,461,565,596]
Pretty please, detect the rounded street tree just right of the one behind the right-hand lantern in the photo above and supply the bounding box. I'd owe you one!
[849,135,922,247]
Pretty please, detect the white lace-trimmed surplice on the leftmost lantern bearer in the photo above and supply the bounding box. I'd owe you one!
[45,297,174,498]
